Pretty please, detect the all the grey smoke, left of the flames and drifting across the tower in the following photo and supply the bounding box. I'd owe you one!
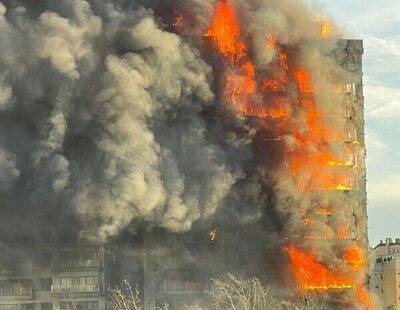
[0,0,366,306]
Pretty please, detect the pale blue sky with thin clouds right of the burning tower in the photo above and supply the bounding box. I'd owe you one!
[309,0,400,246]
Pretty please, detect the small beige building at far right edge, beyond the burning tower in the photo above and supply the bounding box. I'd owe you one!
[371,238,400,309]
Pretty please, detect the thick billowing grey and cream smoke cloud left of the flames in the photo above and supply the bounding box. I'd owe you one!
[0,0,260,240]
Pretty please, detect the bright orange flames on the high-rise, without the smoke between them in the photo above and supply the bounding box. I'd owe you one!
[205,0,372,309]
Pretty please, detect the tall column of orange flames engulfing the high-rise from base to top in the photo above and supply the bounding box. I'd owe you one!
[204,1,373,309]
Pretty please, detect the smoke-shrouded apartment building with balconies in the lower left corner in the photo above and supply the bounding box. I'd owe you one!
[0,244,111,310]
